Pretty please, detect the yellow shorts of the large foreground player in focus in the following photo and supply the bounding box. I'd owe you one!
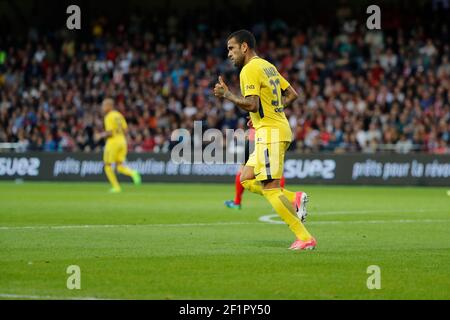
[245,141,290,181]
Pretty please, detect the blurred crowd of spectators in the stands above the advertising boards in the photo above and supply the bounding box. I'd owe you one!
[0,6,450,154]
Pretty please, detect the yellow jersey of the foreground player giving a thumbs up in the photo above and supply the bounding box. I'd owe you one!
[240,57,292,143]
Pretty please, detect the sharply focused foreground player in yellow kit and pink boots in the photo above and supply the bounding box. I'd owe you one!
[214,30,317,250]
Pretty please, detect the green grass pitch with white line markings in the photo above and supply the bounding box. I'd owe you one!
[0,182,450,299]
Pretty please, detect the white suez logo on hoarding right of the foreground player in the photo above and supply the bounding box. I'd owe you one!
[284,159,336,180]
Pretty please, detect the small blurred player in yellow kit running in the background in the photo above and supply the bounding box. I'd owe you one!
[102,99,141,193]
